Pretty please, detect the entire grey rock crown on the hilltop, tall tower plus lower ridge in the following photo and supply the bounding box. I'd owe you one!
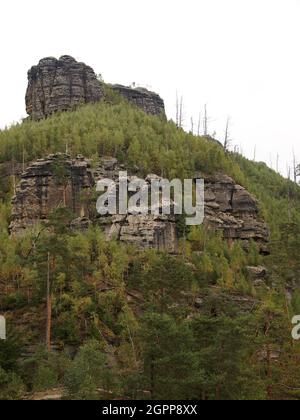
[25,55,165,120]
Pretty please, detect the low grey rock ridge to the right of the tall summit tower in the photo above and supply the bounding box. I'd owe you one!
[111,85,166,117]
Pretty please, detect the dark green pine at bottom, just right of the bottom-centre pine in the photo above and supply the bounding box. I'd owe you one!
[193,315,264,400]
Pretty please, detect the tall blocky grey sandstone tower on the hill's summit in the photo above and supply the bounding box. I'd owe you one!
[26,56,104,120]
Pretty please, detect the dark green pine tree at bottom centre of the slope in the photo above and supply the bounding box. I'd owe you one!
[141,312,204,400]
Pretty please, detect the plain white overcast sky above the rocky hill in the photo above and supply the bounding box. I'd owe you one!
[0,0,300,171]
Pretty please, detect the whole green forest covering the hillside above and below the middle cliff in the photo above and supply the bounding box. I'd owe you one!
[0,94,300,400]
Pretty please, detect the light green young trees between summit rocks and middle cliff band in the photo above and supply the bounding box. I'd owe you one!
[0,101,238,179]
